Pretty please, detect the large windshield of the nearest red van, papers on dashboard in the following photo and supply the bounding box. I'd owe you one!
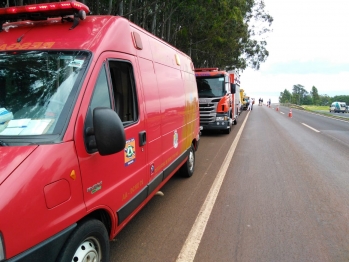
[0,50,89,137]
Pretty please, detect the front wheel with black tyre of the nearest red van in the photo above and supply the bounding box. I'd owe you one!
[58,219,109,262]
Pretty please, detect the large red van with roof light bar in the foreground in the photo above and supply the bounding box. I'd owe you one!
[0,1,200,262]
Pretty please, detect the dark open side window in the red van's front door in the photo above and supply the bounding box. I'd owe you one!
[109,60,138,126]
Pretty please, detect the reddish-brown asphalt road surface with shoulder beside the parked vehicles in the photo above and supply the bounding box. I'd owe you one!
[111,105,349,262]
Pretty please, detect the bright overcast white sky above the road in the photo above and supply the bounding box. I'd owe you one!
[240,0,349,103]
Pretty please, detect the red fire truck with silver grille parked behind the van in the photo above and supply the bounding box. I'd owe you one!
[195,68,240,134]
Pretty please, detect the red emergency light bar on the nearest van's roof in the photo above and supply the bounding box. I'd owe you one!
[0,0,90,30]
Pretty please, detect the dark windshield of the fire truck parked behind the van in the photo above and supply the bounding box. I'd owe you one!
[196,76,226,98]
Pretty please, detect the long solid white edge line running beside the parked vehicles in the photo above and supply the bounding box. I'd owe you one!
[176,111,251,262]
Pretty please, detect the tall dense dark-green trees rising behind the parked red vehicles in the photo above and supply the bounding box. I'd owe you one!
[0,0,273,70]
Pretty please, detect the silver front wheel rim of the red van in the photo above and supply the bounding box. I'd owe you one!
[72,237,102,262]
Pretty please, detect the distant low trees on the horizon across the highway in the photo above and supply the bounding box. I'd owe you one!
[279,84,349,106]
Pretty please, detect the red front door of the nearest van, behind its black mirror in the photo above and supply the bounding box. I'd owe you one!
[76,53,149,227]
